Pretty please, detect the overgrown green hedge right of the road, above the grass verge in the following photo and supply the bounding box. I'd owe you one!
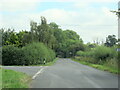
[76,46,118,63]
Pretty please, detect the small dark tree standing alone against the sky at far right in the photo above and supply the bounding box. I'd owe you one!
[105,35,117,47]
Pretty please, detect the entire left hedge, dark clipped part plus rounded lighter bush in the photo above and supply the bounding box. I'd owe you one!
[2,43,55,65]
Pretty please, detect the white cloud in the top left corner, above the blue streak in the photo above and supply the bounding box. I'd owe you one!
[0,0,39,11]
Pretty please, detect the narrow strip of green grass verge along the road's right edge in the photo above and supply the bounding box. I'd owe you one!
[72,59,118,74]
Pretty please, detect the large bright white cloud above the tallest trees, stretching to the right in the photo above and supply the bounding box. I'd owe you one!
[23,7,118,42]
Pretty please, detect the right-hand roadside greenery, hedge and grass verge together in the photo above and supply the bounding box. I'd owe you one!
[75,45,119,73]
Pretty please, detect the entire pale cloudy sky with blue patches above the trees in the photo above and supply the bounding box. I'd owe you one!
[0,0,118,43]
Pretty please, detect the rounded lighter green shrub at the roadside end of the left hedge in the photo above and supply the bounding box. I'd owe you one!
[23,43,55,65]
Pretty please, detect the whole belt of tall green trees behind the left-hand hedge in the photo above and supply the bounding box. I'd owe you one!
[2,17,85,57]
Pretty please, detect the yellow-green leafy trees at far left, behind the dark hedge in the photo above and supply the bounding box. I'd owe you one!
[0,29,31,47]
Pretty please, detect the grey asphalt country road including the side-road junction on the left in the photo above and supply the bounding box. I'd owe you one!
[3,59,118,88]
